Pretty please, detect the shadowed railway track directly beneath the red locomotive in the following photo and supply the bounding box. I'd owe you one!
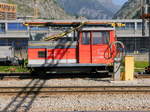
[0,72,150,79]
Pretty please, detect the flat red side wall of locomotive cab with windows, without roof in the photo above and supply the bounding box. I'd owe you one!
[79,31,110,63]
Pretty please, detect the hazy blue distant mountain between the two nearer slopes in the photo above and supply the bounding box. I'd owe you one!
[57,0,120,19]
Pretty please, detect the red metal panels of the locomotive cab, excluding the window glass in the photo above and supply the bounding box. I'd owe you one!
[79,31,115,64]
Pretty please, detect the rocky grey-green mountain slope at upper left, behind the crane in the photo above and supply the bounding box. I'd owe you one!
[0,0,73,19]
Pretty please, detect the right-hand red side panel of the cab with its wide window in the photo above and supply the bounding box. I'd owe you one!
[91,31,110,63]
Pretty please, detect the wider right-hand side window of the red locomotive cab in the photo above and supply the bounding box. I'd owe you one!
[92,31,109,45]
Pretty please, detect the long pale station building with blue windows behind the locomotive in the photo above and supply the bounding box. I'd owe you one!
[0,19,149,58]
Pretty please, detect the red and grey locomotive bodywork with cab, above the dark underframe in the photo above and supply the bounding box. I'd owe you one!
[28,28,116,67]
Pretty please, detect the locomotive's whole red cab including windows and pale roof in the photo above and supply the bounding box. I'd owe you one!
[79,28,115,64]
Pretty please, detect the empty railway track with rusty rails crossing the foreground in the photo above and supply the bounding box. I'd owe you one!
[0,86,150,94]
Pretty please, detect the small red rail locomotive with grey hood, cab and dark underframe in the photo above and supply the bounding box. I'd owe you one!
[28,23,116,72]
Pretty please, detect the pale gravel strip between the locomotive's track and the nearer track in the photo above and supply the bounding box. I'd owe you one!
[0,78,150,87]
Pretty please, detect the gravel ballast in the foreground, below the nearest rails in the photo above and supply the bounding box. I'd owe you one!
[0,94,150,112]
